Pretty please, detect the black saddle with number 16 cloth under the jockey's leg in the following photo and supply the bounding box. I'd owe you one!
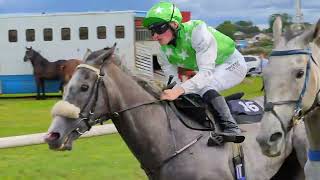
[170,93,263,131]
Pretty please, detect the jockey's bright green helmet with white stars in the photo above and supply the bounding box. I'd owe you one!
[142,1,182,28]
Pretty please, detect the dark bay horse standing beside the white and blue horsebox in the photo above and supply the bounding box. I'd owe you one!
[23,47,82,99]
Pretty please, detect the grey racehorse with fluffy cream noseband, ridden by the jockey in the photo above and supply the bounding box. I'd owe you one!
[45,45,303,180]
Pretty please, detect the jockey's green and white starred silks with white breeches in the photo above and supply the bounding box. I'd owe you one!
[158,21,247,95]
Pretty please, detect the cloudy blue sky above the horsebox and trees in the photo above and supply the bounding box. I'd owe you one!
[0,0,320,29]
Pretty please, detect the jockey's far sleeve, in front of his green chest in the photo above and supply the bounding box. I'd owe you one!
[158,51,181,84]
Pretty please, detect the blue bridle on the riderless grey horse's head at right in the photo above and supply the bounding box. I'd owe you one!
[264,49,319,133]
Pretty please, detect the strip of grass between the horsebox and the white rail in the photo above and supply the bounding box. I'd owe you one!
[0,98,58,137]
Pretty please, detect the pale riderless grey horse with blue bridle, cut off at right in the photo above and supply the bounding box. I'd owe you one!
[257,17,320,180]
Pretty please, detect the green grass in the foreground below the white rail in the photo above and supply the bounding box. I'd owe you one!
[0,134,147,180]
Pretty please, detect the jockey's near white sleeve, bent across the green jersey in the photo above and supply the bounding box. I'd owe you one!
[180,23,217,93]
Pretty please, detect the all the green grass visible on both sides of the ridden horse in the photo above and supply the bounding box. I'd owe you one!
[0,77,262,180]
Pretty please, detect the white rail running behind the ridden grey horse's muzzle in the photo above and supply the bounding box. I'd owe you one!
[0,124,117,148]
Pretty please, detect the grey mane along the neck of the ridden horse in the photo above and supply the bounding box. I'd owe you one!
[112,54,164,98]
